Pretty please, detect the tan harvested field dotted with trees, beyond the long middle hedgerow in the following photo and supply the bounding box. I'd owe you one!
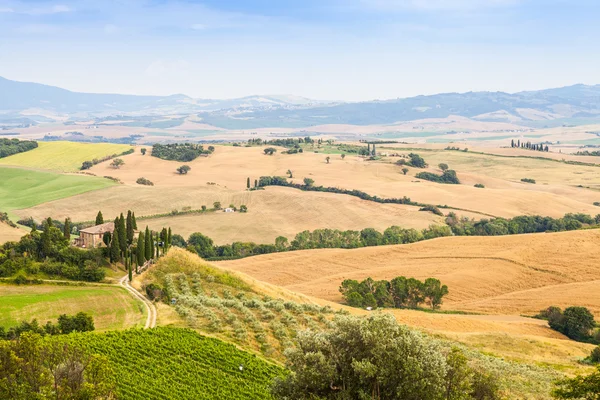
[77,146,600,218]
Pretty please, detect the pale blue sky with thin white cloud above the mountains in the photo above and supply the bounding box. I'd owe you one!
[0,0,600,101]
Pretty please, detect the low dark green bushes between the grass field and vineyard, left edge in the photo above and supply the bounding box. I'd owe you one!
[0,312,96,340]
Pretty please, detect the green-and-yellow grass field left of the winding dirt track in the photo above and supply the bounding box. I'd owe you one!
[0,284,146,330]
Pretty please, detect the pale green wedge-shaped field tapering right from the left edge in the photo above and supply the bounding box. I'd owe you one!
[0,166,116,216]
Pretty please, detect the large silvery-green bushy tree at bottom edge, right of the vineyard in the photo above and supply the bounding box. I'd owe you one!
[273,314,502,400]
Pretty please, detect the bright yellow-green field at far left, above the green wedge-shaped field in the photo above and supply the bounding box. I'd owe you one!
[0,142,131,172]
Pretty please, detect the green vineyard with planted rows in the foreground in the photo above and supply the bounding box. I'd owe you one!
[51,328,282,400]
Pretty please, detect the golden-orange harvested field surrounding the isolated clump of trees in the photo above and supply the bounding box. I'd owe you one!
[218,230,600,316]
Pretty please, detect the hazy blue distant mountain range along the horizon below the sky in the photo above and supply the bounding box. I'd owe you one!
[0,77,600,129]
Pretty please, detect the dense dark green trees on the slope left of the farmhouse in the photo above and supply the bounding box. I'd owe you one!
[0,218,105,282]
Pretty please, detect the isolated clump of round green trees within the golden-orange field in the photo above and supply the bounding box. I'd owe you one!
[339,276,448,310]
